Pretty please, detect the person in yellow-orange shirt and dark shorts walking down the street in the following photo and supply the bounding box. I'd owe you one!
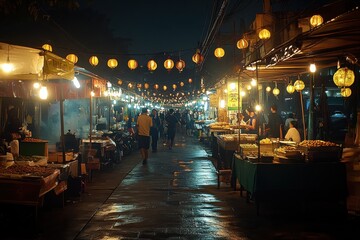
[136,108,153,164]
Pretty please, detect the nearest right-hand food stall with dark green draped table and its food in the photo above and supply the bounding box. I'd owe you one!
[232,140,348,216]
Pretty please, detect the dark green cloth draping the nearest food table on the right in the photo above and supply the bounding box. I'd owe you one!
[232,154,348,213]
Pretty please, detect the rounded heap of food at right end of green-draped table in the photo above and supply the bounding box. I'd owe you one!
[299,140,342,162]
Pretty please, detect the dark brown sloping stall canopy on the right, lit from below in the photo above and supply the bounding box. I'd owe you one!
[243,8,360,81]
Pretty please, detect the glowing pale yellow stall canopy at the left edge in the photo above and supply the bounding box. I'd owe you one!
[0,43,74,81]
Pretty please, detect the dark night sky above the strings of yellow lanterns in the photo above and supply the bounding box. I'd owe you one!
[0,0,338,89]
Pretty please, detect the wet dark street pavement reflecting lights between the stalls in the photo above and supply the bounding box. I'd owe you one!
[0,134,360,240]
